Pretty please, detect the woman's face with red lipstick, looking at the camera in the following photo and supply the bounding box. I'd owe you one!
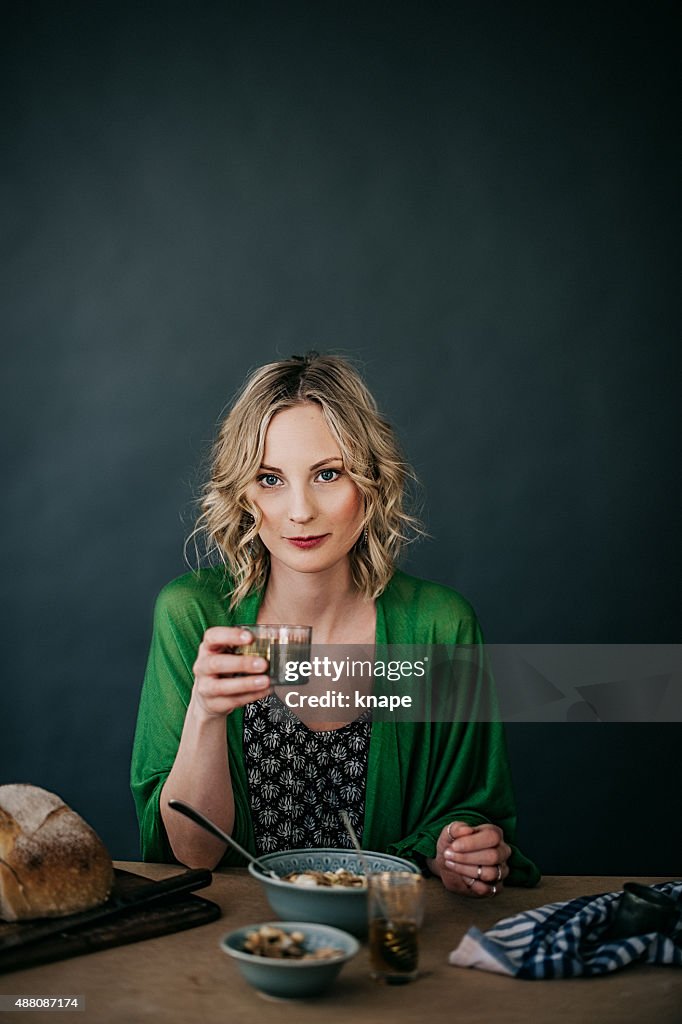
[248,402,364,572]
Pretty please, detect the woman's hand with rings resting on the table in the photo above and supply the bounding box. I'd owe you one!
[427,821,511,897]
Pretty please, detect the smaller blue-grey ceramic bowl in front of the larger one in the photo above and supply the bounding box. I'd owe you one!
[220,921,359,999]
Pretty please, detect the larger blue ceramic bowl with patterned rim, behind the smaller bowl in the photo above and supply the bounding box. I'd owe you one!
[249,848,421,936]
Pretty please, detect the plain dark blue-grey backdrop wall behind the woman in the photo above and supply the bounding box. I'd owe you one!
[0,0,682,873]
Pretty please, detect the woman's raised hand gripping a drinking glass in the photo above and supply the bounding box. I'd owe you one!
[191,626,270,718]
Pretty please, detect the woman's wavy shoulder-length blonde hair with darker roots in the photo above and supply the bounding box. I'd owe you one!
[188,352,424,608]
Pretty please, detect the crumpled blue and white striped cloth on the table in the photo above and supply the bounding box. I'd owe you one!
[450,882,682,979]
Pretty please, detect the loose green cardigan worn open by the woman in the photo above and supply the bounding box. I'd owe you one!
[131,567,540,886]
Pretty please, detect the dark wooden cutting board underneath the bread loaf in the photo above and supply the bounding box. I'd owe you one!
[0,867,220,974]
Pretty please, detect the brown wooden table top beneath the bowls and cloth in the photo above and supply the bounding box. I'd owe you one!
[0,862,682,1024]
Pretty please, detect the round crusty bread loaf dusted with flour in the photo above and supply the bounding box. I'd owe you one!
[0,784,114,921]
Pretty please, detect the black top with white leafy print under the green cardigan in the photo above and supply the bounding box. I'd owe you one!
[243,694,372,853]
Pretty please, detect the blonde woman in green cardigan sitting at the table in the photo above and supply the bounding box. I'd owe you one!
[132,353,539,897]
